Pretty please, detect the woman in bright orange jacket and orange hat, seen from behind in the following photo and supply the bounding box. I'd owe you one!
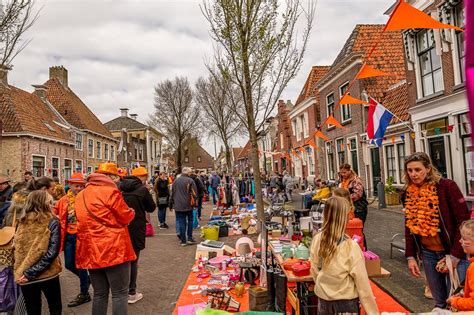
[76,163,137,315]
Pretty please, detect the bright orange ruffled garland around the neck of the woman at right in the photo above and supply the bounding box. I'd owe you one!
[405,184,439,236]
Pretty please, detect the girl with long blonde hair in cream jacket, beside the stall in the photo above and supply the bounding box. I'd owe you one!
[310,197,379,315]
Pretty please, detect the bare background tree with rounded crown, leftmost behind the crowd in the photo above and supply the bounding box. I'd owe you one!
[151,77,200,173]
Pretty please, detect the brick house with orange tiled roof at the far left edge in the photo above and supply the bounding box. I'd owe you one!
[0,68,79,181]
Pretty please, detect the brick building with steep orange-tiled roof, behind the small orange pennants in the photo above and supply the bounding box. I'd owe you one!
[316,25,409,193]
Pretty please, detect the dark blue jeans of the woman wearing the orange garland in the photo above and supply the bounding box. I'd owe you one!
[422,249,469,308]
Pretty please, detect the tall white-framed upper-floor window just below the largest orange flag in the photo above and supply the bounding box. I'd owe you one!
[416,30,443,97]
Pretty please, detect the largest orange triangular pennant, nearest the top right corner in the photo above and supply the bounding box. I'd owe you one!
[384,0,463,31]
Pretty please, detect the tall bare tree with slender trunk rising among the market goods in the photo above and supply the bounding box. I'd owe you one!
[201,0,316,220]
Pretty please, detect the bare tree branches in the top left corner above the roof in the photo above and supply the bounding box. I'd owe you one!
[0,0,39,67]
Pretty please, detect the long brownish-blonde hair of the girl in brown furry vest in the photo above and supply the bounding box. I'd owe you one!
[20,190,53,222]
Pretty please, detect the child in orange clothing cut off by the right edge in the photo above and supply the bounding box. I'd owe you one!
[447,219,474,311]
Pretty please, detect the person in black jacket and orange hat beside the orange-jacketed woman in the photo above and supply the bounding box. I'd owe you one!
[120,167,156,304]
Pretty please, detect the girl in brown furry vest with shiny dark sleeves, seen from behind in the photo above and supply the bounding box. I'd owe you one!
[14,190,62,315]
